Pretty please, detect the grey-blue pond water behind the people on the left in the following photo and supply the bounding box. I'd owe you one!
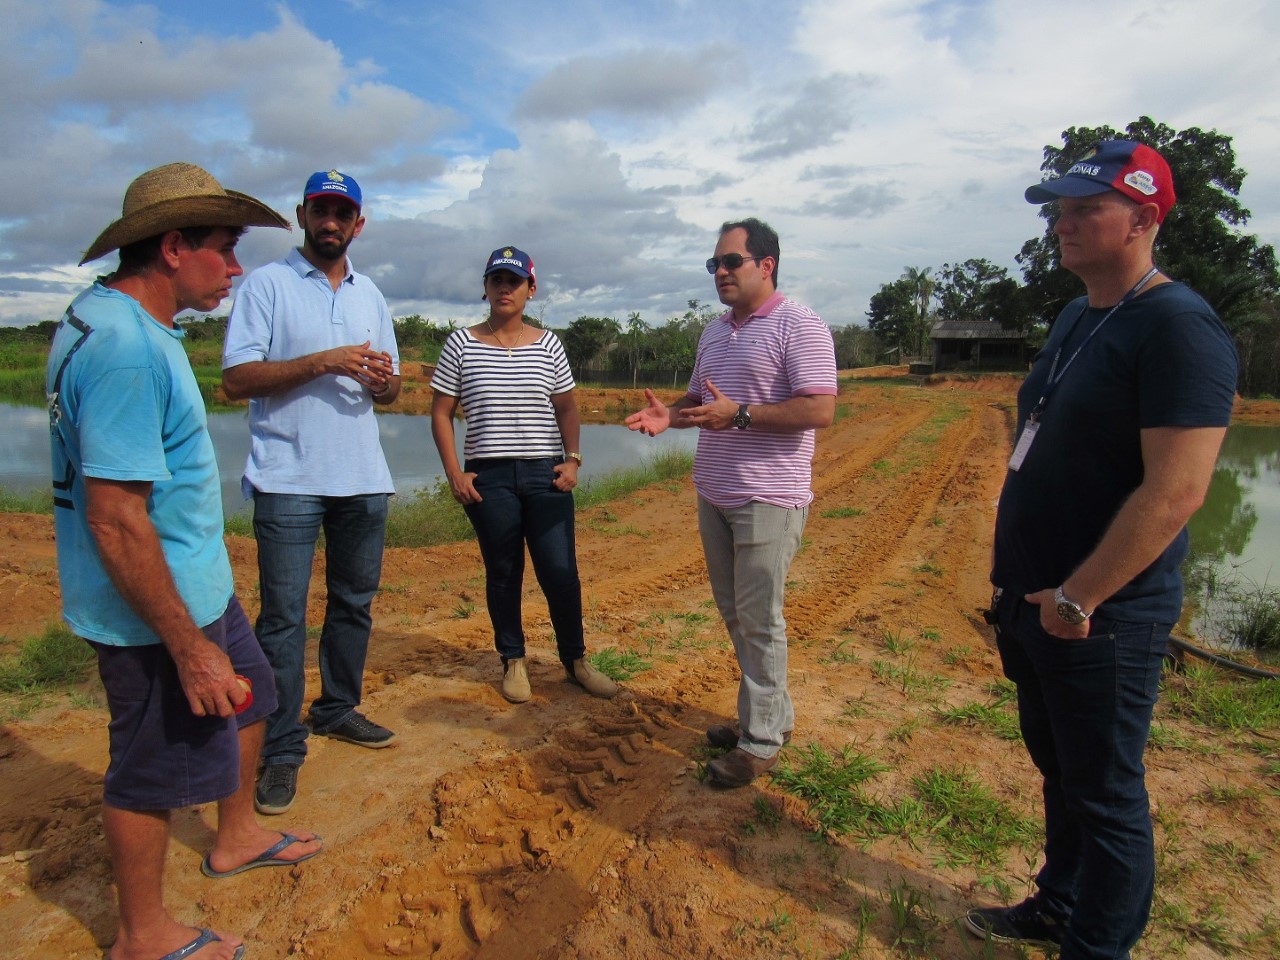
[0,404,698,515]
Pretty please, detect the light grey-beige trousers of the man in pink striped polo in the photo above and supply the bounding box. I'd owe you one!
[698,497,809,758]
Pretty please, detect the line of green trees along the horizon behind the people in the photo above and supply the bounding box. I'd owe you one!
[0,116,1280,397]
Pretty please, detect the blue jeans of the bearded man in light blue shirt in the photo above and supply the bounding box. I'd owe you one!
[253,493,387,765]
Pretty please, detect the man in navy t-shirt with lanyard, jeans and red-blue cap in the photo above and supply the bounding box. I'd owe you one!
[966,141,1236,960]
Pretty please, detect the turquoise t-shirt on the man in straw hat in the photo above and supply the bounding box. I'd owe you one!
[45,283,234,646]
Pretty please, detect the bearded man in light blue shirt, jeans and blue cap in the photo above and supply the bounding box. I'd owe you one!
[223,170,399,814]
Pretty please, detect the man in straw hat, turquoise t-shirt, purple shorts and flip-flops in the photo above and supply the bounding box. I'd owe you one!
[46,164,321,960]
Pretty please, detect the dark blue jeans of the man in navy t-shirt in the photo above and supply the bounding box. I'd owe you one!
[996,595,1172,960]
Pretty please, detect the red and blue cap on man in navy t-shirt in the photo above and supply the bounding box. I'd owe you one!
[1027,140,1178,223]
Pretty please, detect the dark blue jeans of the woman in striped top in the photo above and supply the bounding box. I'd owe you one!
[465,458,586,666]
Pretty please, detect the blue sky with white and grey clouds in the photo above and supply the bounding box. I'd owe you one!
[0,0,1280,326]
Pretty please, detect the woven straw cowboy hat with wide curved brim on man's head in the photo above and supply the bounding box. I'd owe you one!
[81,164,292,265]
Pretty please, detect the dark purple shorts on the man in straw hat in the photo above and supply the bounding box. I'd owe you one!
[88,596,275,812]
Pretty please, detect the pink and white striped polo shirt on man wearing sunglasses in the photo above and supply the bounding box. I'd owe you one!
[689,293,836,508]
